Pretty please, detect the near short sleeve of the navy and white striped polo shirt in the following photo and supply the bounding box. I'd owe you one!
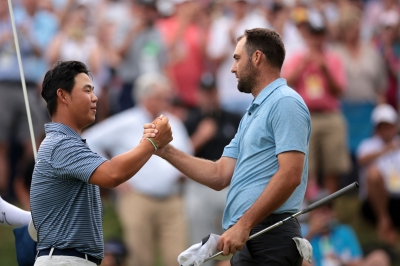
[51,138,107,183]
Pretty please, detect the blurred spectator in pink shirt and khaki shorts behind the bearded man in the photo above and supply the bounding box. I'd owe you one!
[283,12,350,197]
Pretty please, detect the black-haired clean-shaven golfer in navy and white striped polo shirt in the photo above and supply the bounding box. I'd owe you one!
[30,61,172,266]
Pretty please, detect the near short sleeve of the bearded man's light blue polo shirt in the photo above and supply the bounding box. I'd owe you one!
[269,96,311,155]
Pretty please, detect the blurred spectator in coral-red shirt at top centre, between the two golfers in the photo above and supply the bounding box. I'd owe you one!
[158,0,206,106]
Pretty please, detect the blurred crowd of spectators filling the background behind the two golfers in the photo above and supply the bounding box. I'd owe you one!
[0,0,400,265]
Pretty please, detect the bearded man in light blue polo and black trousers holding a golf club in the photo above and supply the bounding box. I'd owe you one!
[145,28,311,266]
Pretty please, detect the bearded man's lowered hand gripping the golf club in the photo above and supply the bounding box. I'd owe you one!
[217,222,250,256]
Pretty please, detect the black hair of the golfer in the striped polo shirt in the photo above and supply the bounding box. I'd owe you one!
[42,61,90,117]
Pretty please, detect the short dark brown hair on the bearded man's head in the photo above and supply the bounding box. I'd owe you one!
[237,28,286,70]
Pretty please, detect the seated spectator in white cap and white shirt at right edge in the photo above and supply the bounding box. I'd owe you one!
[357,104,400,244]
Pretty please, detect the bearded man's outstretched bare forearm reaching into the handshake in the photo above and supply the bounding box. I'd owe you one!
[158,145,230,190]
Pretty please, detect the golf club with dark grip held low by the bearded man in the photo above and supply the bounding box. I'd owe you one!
[204,182,358,262]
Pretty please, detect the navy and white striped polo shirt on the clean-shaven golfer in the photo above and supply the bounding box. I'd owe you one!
[30,123,106,259]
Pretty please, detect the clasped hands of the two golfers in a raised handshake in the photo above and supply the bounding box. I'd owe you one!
[142,115,173,151]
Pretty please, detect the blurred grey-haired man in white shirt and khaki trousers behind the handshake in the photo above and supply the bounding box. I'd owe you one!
[83,73,192,266]
